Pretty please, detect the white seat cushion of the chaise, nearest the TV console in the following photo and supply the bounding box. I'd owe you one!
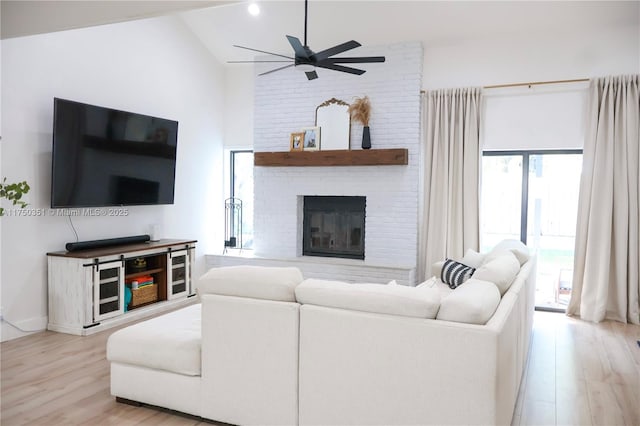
[107,304,201,376]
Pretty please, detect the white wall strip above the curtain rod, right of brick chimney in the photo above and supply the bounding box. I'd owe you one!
[422,25,640,90]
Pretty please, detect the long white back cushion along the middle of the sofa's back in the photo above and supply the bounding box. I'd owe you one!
[296,279,440,319]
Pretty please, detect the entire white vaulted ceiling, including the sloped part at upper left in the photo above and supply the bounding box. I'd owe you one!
[1,0,640,66]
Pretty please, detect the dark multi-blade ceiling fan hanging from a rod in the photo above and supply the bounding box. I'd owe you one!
[229,0,385,80]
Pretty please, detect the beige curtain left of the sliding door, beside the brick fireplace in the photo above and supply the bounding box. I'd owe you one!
[418,88,482,281]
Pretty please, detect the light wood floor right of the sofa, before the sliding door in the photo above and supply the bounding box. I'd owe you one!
[512,312,640,426]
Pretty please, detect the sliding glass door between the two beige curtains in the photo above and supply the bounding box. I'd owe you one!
[480,150,582,310]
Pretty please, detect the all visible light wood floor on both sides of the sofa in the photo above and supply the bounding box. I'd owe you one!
[0,312,640,426]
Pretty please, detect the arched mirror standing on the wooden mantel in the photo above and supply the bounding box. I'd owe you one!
[316,98,351,150]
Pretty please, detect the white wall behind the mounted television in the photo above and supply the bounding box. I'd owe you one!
[0,17,224,340]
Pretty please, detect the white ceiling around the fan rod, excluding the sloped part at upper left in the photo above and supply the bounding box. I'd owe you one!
[180,0,640,65]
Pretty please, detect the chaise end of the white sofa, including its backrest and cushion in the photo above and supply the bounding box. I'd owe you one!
[107,267,302,425]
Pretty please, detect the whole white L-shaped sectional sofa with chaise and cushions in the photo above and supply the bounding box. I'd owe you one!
[107,242,535,425]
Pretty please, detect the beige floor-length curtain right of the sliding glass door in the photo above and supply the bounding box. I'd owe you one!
[567,75,640,324]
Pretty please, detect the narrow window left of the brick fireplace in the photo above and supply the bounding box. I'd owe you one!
[225,150,253,249]
